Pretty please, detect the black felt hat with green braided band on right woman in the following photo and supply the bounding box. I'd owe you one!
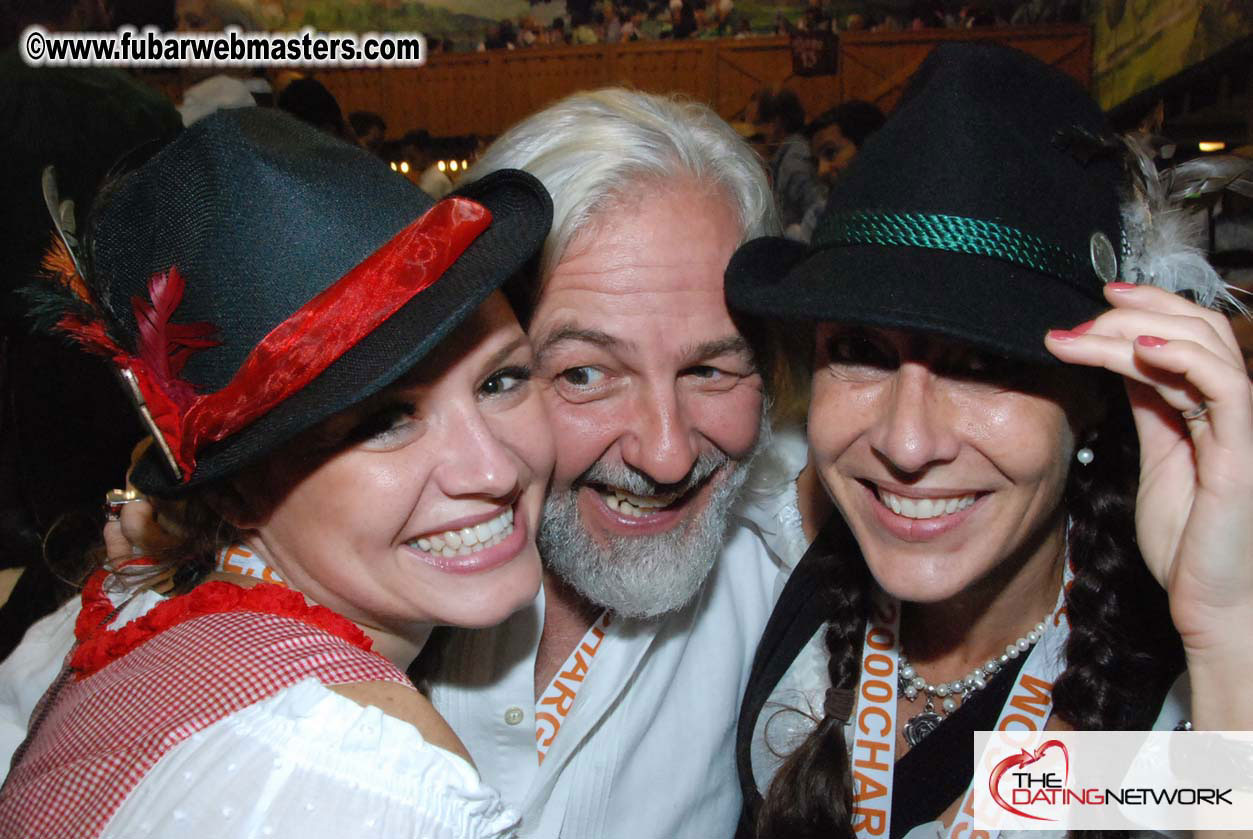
[727,44,1123,363]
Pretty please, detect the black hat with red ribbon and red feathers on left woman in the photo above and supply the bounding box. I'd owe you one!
[53,108,553,496]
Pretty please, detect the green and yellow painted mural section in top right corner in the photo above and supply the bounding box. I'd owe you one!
[1093,0,1253,108]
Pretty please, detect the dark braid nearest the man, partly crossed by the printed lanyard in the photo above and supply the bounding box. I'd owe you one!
[757,527,870,839]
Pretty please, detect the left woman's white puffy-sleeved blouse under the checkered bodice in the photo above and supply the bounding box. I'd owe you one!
[0,591,519,839]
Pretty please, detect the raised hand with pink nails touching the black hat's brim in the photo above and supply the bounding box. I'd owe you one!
[1045,284,1253,729]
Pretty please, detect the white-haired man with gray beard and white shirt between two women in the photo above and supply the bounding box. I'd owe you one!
[430,90,806,839]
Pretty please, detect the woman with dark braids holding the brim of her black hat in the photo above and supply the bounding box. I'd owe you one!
[727,44,1253,839]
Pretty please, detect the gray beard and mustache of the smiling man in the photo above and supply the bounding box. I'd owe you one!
[538,422,769,619]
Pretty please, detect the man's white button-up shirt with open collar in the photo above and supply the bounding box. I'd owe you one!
[431,433,806,839]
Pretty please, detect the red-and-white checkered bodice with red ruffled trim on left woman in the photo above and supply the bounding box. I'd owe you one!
[0,579,410,839]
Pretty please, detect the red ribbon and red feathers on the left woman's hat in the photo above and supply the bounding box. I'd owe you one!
[58,197,491,483]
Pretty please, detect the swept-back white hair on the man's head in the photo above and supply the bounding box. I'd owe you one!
[466,88,778,278]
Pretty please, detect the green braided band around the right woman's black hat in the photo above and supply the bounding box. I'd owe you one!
[813,212,1093,293]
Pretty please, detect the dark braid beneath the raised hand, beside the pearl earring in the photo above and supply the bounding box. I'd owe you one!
[1053,387,1184,731]
